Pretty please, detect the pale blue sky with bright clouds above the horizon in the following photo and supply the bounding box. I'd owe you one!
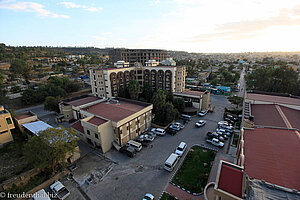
[0,0,300,53]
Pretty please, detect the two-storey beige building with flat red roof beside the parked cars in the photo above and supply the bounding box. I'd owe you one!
[72,98,153,153]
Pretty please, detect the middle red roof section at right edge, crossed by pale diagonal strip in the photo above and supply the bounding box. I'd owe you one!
[251,104,300,129]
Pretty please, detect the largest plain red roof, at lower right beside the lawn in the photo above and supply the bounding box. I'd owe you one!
[244,128,300,191]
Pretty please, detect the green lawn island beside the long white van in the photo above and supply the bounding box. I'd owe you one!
[172,146,216,193]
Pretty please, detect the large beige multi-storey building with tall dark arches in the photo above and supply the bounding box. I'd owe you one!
[90,63,186,98]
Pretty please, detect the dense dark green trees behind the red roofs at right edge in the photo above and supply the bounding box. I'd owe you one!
[246,66,300,96]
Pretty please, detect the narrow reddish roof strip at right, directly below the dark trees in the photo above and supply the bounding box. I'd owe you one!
[246,93,300,106]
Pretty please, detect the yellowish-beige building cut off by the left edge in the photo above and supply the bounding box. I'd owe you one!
[0,105,15,147]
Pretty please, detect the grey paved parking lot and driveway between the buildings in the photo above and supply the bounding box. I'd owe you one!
[63,95,233,200]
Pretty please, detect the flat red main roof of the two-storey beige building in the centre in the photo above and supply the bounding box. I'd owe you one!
[83,100,151,122]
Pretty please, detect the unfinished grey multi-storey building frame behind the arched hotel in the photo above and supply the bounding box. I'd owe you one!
[108,48,167,66]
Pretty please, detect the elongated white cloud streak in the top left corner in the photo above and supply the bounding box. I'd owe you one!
[0,1,69,18]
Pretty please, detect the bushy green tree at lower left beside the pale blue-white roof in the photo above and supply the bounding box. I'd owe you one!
[23,127,78,173]
